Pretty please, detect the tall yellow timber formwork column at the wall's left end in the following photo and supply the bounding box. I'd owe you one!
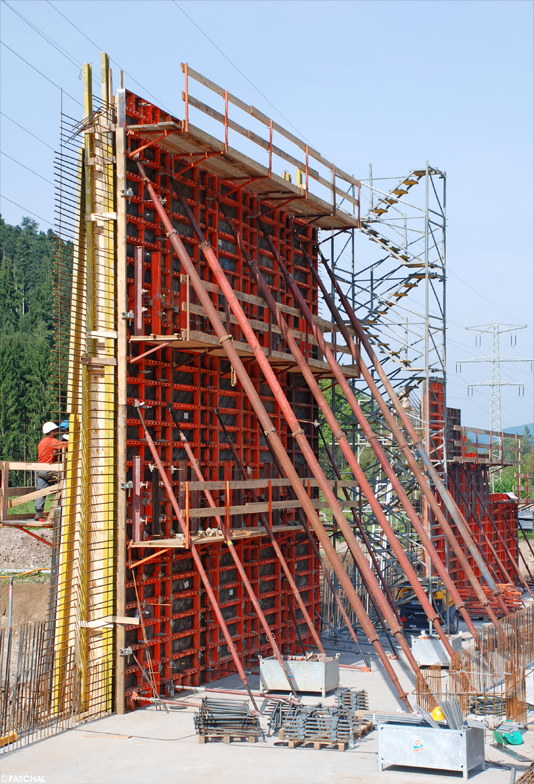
[55,54,117,718]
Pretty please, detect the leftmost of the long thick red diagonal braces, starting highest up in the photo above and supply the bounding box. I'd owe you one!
[137,162,417,711]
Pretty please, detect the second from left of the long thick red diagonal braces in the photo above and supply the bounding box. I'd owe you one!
[180,198,426,674]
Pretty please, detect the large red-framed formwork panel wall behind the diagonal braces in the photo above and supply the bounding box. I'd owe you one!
[125,92,320,695]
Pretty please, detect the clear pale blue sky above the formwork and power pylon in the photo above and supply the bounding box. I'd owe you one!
[0,0,534,427]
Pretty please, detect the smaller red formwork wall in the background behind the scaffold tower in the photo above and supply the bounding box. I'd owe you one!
[423,381,521,614]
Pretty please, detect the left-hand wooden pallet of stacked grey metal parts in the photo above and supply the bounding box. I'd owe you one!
[194,697,263,743]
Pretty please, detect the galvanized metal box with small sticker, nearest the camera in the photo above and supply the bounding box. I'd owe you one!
[378,724,485,779]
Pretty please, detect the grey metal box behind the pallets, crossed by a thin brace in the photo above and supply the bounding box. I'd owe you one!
[259,654,339,697]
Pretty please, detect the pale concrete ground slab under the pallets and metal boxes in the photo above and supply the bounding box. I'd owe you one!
[1,632,534,784]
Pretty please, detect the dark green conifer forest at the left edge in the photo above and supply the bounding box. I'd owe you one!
[0,218,56,460]
